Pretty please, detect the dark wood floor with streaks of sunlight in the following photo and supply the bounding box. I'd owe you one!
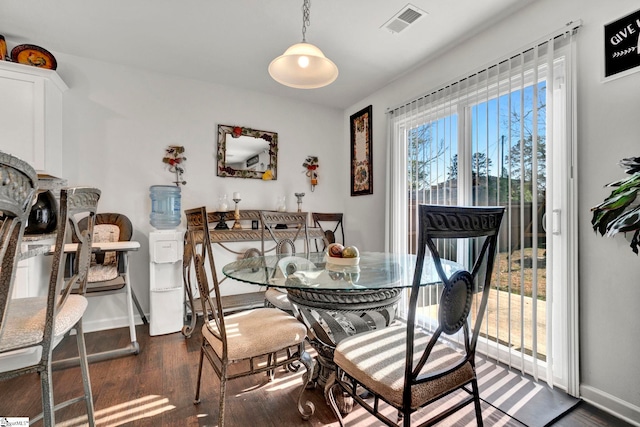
[0,326,629,427]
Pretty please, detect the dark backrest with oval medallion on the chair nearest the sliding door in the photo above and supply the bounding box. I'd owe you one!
[404,205,504,407]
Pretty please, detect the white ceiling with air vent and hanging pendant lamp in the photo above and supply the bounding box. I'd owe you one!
[0,0,534,109]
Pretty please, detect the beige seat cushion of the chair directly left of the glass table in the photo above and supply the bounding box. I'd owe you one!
[202,308,307,360]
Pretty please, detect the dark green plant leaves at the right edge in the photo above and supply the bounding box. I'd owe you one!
[591,157,640,254]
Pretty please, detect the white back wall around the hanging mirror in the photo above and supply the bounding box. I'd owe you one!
[56,53,349,331]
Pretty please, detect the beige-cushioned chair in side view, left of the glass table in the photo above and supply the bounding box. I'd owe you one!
[185,207,315,427]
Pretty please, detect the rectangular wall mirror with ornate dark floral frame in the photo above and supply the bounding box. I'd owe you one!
[218,125,278,179]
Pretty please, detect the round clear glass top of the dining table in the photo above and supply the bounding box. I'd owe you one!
[222,252,462,292]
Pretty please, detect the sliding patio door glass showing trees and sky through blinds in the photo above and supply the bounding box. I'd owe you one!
[406,72,546,360]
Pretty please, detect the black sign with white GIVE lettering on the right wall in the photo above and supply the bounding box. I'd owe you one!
[604,10,640,79]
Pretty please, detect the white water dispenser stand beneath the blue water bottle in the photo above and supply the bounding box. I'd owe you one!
[149,230,184,335]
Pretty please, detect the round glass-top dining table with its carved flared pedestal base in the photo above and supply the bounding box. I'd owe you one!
[222,252,462,390]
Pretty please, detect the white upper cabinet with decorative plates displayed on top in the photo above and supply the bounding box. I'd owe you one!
[0,61,68,176]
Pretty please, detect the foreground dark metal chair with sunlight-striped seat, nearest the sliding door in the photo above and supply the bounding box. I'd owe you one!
[329,205,504,427]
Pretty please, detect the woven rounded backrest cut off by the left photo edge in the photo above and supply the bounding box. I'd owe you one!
[0,152,38,336]
